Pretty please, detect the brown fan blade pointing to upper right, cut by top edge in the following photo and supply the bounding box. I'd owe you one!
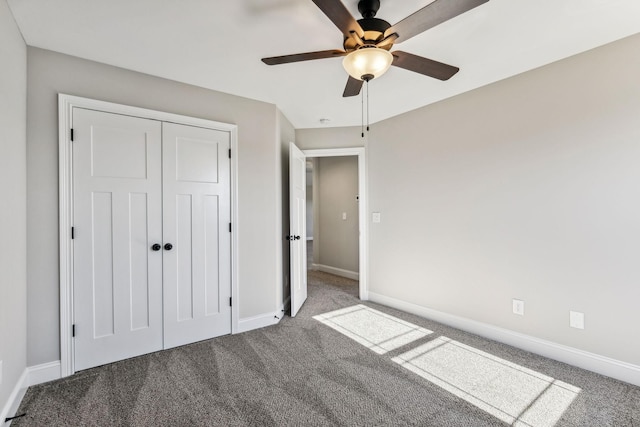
[384,0,489,43]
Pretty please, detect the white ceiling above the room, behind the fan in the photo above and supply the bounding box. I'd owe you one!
[8,0,640,128]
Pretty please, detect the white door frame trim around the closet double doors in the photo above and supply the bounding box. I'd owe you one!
[58,93,240,377]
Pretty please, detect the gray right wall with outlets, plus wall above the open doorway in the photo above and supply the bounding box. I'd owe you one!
[296,35,640,365]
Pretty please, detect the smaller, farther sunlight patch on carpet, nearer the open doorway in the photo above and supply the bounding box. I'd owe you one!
[313,304,433,354]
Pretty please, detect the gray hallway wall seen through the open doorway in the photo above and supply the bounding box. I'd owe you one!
[314,156,359,273]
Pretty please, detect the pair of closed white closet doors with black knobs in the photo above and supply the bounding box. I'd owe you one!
[71,107,231,371]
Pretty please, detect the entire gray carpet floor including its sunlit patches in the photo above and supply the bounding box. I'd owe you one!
[12,272,640,427]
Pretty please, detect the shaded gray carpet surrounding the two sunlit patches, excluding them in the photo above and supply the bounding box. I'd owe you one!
[12,272,640,426]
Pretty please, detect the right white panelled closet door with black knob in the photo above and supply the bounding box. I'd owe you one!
[163,123,231,348]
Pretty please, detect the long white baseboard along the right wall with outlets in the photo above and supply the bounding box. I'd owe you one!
[368,292,640,386]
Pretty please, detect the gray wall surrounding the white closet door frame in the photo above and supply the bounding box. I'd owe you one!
[27,47,282,365]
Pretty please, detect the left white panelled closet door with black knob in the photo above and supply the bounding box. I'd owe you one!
[73,108,163,370]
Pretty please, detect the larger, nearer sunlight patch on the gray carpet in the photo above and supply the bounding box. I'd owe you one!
[392,337,581,427]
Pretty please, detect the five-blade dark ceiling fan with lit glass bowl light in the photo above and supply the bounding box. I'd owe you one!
[262,0,489,97]
